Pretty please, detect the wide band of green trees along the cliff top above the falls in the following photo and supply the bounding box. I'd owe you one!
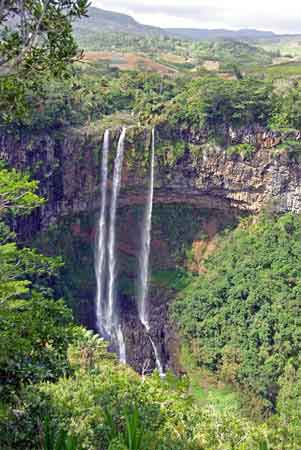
[2,59,301,141]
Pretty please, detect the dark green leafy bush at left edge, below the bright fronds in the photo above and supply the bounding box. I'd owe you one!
[0,298,72,397]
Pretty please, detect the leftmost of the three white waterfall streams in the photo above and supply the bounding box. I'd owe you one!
[95,130,110,334]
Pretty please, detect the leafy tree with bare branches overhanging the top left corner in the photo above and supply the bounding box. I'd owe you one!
[0,0,88,123]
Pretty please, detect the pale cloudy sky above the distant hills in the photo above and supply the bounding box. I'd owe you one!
[92,0,301,33]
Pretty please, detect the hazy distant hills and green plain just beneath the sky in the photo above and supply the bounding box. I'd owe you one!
[74,7,299,70]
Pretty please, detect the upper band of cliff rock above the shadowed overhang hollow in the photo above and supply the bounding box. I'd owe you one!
[0,123,301,232]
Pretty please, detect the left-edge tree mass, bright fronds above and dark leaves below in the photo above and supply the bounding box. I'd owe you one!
[0,163,72,398]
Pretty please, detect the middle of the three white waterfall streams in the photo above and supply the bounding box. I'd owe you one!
[106,128,126,338]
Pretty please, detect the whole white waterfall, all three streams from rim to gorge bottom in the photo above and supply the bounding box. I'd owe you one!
[95,128,164,376]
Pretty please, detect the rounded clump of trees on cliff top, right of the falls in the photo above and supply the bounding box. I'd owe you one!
[161,77,273,133]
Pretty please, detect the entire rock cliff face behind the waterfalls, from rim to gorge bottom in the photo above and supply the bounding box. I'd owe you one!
[0,126,301,372]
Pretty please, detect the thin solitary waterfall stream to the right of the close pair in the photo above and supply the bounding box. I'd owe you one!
[138,129,155,331]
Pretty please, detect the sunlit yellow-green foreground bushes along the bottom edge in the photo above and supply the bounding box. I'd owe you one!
[0,329,300,450]
